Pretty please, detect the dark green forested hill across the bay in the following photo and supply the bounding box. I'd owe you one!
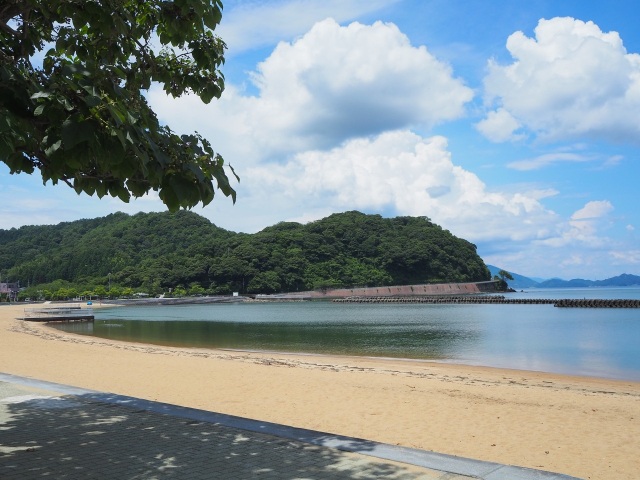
[0,211,490,296]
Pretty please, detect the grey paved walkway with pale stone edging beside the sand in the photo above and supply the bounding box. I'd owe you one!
[0,373,573,480]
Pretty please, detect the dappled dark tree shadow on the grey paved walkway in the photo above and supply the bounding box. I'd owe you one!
[0,395,442,480]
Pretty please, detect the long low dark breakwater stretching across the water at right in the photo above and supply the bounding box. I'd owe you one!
[333,295,640,308]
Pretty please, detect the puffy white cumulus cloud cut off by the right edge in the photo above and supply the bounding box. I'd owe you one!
[476,17,640,143]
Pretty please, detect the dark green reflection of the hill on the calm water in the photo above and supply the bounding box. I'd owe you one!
[59,303,480,359]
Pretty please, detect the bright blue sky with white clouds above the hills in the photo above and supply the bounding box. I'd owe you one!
[0,0,640,279]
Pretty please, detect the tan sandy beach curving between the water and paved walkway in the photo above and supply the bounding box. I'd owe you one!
[0,306,640,480]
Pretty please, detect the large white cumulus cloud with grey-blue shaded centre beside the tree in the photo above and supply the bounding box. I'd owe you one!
[150,19,473,163]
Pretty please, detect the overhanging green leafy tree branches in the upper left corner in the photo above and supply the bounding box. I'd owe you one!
[0,0,237,210]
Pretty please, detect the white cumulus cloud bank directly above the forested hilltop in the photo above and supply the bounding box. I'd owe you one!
[249,130,557,241]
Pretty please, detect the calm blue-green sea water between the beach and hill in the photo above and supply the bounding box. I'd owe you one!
[55,288,640,381]
